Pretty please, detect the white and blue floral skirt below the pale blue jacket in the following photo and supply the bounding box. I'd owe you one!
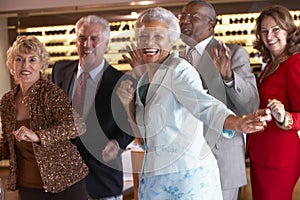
[139,166,223,200]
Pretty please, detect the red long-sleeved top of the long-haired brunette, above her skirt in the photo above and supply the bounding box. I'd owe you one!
[248,53,300,167]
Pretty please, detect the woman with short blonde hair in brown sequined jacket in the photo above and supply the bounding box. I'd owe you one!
[0,36,88,200]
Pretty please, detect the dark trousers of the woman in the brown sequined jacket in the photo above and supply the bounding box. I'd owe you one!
[19,180,87,200]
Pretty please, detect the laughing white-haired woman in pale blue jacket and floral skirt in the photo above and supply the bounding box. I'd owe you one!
[117,7,270,200]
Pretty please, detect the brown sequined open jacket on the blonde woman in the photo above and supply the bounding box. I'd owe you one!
[0,79,88,193]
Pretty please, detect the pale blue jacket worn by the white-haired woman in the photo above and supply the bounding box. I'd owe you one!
[136,52,233,176]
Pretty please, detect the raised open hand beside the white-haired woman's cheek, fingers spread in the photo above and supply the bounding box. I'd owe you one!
[122,43,145,79]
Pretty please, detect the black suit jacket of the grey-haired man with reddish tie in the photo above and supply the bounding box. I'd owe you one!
[52,60,133,199]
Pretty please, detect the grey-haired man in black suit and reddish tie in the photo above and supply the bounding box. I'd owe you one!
[52,15,133,200]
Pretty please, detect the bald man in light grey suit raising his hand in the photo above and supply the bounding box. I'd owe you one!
[179,0,259,200]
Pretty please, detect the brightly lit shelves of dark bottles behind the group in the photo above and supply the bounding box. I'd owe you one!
[20,11,300,73]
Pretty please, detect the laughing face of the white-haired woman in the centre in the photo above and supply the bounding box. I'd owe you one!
[136,20,172,63]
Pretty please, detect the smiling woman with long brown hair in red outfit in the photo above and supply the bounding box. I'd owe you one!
[248,5,300,200]
